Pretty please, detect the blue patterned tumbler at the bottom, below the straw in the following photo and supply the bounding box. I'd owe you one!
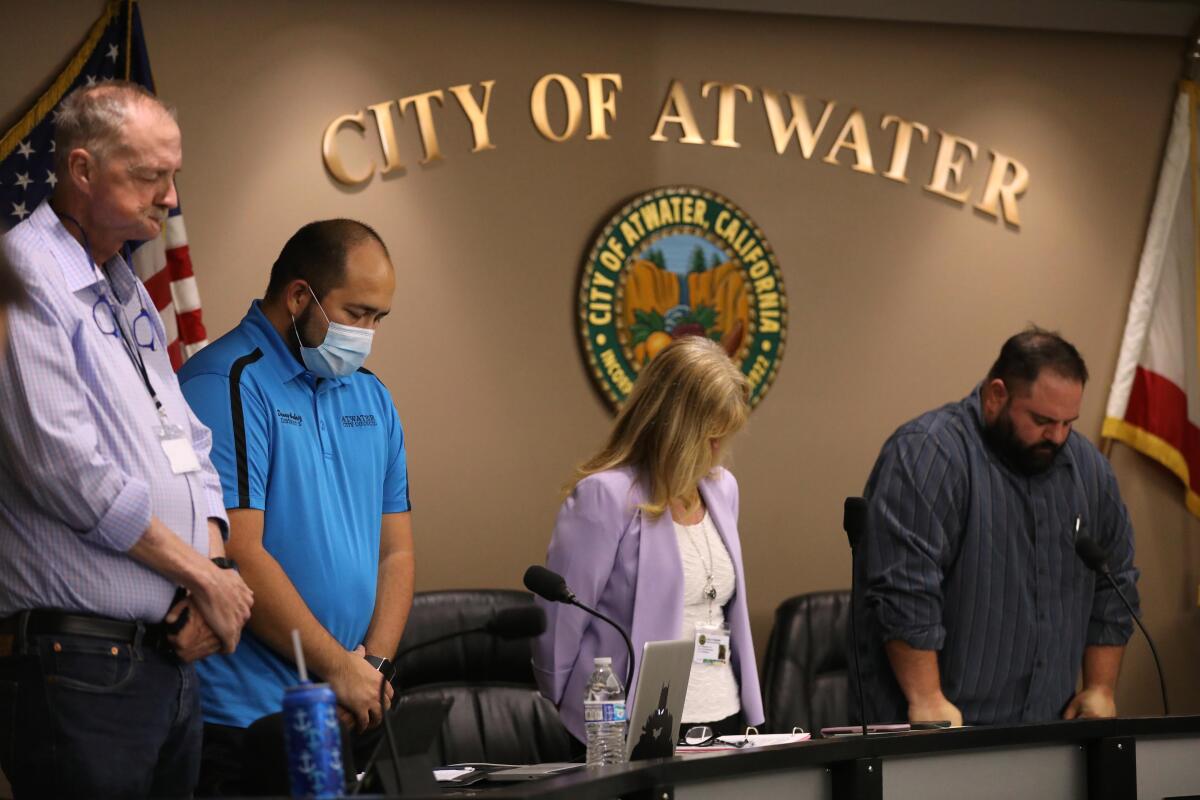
[283,684,346,798]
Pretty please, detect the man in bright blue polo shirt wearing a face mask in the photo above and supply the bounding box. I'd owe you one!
[179,219,413,795]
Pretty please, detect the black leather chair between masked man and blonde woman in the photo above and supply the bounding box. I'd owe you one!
[395,589,582,764]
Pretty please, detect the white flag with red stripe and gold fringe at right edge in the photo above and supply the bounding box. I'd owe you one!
[1103,80,1200,516]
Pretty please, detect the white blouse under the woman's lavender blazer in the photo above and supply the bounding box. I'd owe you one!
[674,511,748,723]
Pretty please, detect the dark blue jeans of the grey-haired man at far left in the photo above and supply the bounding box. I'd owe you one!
[0,634,202,800]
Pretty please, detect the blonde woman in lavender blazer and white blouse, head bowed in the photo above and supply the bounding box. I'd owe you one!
[534,336,763,741]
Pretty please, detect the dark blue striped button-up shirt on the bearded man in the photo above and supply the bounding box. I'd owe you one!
[852,387,1138,724]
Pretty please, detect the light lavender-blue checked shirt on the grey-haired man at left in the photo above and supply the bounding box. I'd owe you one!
[0,203,226,622]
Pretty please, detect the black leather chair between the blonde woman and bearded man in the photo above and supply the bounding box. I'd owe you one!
[762,591,850,733]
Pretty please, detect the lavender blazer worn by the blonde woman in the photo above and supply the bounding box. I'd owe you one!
[533,468,763,740]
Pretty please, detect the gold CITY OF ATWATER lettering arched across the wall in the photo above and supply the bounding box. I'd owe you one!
[320,72,1030,228]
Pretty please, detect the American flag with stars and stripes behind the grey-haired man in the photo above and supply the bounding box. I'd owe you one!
[0,0,208,369]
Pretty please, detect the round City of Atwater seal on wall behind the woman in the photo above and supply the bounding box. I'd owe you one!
[578,186,787,409]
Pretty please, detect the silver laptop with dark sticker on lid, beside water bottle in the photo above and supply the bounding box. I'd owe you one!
[625,639,695,762]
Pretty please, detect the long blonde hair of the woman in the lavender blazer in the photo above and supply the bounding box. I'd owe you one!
[566,336,750,517]
